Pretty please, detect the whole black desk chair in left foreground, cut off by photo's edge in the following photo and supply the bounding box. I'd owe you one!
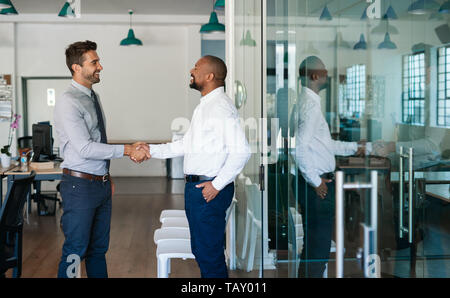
[0,171,36,277]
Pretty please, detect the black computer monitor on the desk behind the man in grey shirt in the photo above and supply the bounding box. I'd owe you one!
[33,123,54,162]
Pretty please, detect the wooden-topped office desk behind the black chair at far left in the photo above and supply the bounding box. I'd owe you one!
[4,162,62,210]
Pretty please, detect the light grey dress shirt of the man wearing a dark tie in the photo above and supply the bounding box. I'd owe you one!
[53,80,124,176]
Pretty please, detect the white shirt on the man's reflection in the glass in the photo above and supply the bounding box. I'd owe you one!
[295,87,358,187]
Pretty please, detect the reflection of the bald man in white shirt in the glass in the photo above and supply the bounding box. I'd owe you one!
[296,56,365,277]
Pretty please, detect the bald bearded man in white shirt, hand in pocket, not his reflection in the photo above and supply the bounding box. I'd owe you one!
[150,56,250,278]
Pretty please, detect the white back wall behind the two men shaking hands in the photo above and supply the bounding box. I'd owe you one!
[0,16,201,176]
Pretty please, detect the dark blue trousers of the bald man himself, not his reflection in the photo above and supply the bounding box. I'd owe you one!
[184,181,234,278]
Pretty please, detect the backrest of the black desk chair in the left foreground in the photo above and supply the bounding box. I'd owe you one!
[0,171,36,230]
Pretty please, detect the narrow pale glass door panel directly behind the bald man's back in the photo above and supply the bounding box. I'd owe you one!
[232,0,275,277]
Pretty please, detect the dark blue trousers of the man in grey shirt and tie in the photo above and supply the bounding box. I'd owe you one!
[58,174,112,278]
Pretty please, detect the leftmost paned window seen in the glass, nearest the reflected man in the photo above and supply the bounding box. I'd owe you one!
[339,65,366,118]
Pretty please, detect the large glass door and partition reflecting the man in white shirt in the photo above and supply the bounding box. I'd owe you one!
[264,0,450,278]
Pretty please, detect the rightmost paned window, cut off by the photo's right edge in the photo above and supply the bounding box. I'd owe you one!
[436,46,450,126]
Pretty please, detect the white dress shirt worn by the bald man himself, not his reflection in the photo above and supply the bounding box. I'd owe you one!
[150,87,250,190]
